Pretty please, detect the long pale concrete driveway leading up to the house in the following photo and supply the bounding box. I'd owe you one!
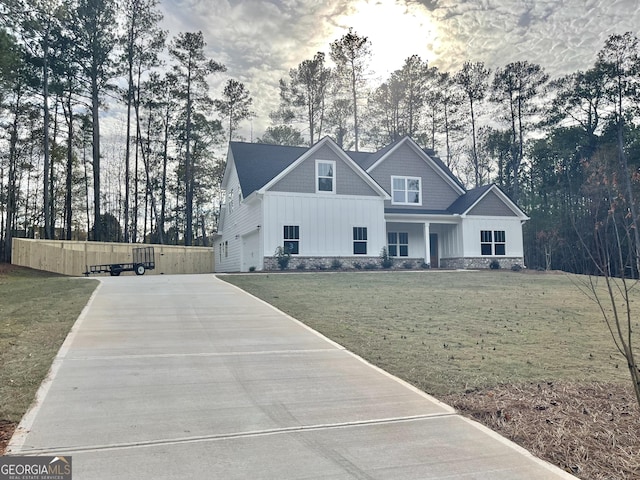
[7,275,574,480]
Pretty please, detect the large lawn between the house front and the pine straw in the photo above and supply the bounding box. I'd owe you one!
[222,271,637,396]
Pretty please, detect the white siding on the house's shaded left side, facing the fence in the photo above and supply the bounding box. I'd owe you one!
[214,164,263,272]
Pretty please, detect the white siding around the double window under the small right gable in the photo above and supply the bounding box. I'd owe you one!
[462,216,524,257]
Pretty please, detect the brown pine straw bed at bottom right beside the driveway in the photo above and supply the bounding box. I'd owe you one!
[441,382,640,480]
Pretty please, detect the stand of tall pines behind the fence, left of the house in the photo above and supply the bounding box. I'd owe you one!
[0,0,252,260]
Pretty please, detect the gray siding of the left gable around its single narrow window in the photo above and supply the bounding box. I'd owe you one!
[270,146,379,196]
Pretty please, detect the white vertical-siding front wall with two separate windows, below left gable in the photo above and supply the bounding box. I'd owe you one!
[263,191,386,257]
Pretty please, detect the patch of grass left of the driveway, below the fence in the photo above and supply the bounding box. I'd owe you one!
[0,264,98,422]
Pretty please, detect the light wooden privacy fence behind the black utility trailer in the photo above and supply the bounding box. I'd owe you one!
[11,238,215,275]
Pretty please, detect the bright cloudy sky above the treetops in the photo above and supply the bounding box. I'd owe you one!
[160,0,640,141]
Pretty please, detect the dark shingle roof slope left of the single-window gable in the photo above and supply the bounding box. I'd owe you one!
[229,142,309,197]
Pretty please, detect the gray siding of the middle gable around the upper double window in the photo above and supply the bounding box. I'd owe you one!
[369,145,460,210]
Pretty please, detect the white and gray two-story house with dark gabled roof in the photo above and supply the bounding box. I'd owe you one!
[215,137,528,272]
